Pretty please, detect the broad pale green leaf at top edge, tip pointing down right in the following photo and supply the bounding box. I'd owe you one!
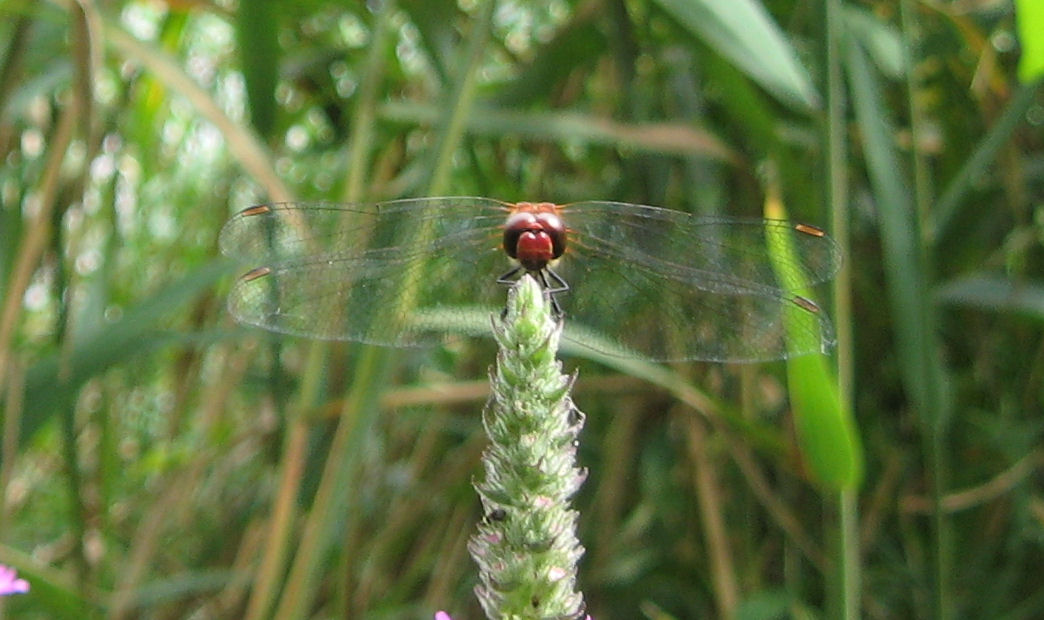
[657,0,820,110]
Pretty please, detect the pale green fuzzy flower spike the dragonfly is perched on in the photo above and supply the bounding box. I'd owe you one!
[468,276,587,620]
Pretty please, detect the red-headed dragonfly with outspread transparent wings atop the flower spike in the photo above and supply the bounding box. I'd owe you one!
[220,197,840,362]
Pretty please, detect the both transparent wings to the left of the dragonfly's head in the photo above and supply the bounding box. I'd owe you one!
[220,198,511,347]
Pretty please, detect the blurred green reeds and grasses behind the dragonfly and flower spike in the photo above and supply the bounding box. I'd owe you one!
[0,0,1044,619]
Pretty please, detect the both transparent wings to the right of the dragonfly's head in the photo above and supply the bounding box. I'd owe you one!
[555,202,840,361]
